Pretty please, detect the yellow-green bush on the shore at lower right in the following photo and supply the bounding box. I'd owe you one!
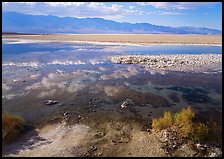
[152,107,209,142]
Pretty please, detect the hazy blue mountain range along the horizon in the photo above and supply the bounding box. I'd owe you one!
[2,12,222,34]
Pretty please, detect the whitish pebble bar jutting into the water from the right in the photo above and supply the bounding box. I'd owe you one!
[109,54,222,71]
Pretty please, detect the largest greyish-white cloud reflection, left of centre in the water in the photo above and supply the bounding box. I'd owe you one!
[25,70,99,97]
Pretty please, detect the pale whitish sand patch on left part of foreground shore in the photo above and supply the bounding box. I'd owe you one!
[3,123,89,157]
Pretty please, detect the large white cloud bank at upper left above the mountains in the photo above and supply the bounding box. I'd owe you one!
[2,2,131,19]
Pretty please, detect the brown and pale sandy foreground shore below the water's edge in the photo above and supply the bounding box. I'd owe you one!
[3,109,221,157]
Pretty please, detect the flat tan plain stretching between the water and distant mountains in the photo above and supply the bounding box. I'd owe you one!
[2,34,222,45]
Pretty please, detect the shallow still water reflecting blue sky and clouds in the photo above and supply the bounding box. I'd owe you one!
[2,41,222,130]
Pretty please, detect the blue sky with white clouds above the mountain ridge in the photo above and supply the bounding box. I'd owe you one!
[2,2,222,30]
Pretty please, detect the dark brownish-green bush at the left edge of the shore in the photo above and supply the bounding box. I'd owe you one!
[2,112,24,143]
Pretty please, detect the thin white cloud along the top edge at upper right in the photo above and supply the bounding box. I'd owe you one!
[136,2,215,9]
